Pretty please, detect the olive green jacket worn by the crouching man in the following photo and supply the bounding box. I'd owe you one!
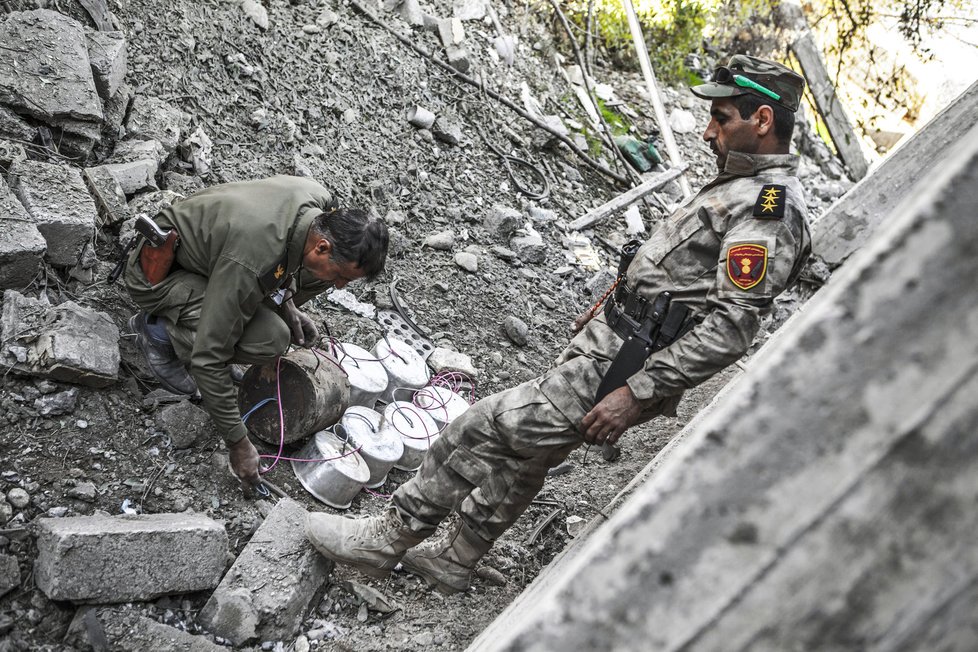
[156,176,330,442]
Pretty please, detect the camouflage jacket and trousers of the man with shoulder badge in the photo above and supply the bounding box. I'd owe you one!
[394,152,810,542]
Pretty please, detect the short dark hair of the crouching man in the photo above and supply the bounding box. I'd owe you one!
[311,208,390,278]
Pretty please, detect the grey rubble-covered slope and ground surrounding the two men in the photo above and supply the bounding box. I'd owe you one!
[0,0,849,650]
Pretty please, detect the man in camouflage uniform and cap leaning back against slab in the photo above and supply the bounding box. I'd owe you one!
[306,55,810,593]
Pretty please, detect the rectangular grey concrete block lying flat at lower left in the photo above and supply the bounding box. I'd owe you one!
[34,514,228,603]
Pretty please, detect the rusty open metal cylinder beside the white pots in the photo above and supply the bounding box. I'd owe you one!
[238,349,350,444]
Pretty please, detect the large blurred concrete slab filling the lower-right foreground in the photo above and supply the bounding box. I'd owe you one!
[470,119,978,651]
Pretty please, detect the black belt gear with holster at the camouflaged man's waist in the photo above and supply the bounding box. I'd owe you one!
[595,279,696,402]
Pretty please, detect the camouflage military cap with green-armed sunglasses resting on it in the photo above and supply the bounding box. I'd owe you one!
[690,54,805,112]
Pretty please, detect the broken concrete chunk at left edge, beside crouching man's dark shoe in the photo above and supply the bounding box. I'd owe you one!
[0,290,120,387]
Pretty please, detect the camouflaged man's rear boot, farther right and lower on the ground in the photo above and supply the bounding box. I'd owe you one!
[401,522,492,595]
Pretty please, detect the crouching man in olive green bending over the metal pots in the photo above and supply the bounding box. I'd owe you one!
[125,176,388,485]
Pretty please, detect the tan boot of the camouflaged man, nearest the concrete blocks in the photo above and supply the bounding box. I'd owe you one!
[306,507,424,578]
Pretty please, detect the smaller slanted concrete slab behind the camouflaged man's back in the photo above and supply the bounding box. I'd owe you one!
[812,82,978,267]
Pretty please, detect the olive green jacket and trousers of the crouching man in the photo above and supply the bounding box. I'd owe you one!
[123,176,331,443]
